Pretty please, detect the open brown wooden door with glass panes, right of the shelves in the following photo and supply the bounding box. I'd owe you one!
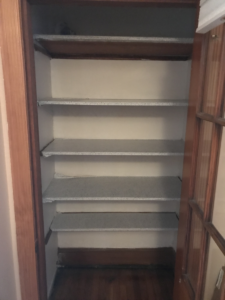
[174,25,225,300]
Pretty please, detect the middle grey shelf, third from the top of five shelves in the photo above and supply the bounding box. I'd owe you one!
[42,139,184,157]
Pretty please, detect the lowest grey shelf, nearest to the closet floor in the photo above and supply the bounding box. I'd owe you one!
[51,213,178,232]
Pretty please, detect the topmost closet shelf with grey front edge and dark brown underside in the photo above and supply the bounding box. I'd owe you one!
[34,35,193,60]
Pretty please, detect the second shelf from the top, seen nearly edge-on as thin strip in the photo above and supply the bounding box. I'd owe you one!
[38,98,188,107]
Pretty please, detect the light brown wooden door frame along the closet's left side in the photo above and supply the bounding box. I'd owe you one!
[0,0,47,300]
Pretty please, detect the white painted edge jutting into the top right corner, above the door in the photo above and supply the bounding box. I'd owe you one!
[196,0,225,34]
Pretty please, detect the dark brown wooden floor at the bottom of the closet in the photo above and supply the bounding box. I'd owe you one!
[50,268,174,300]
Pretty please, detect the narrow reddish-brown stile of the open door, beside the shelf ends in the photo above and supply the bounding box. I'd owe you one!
[173,34,205,300]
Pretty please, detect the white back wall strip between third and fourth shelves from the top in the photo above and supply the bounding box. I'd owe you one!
[55,156,183,177]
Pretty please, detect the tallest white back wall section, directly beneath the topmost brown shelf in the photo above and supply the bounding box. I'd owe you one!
[51,59,190,99]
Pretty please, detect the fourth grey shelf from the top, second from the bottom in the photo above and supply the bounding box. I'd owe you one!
[43,177,181,203]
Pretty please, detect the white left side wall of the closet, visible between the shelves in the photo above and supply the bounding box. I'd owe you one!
[35,52,58,294]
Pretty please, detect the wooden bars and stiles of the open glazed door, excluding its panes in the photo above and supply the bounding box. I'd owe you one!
[174,25,225,300]
